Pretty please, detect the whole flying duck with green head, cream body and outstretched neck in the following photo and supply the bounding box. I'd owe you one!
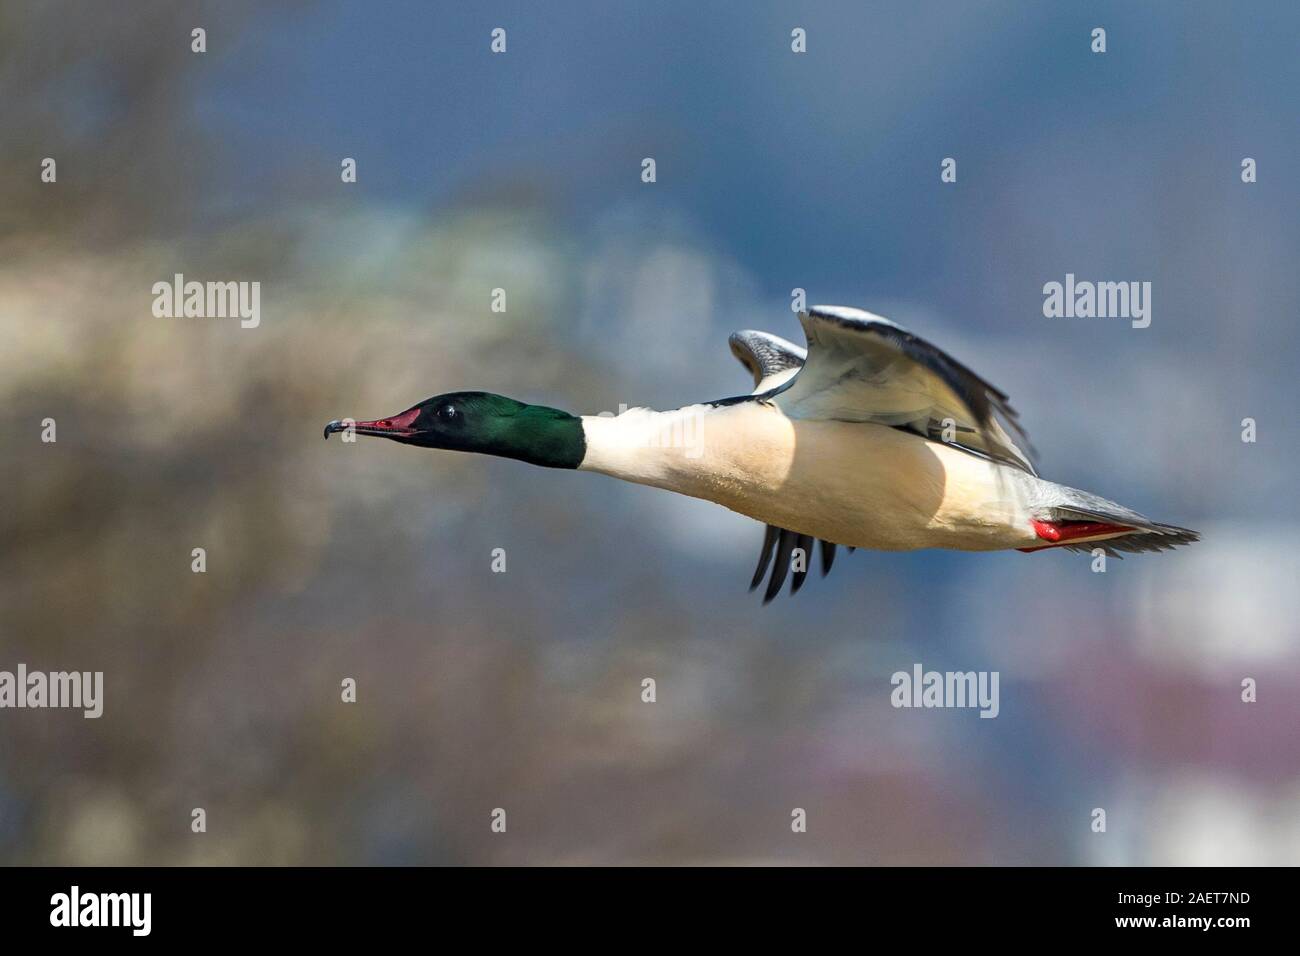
[325,306,1200,604]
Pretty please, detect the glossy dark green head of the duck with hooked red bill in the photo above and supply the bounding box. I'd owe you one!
[325,392,586,468]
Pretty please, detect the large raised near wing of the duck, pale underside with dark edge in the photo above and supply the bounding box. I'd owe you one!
[772,306,1036,475]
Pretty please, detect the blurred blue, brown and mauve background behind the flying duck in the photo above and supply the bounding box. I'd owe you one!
[0,0,1300,865]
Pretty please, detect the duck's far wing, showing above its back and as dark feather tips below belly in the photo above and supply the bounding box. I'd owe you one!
[727,329,853,604]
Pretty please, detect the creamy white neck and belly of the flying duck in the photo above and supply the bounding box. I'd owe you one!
[582,402,1041,550]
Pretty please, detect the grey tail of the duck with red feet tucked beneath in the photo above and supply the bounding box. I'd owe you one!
[1021,485,1201,558]
